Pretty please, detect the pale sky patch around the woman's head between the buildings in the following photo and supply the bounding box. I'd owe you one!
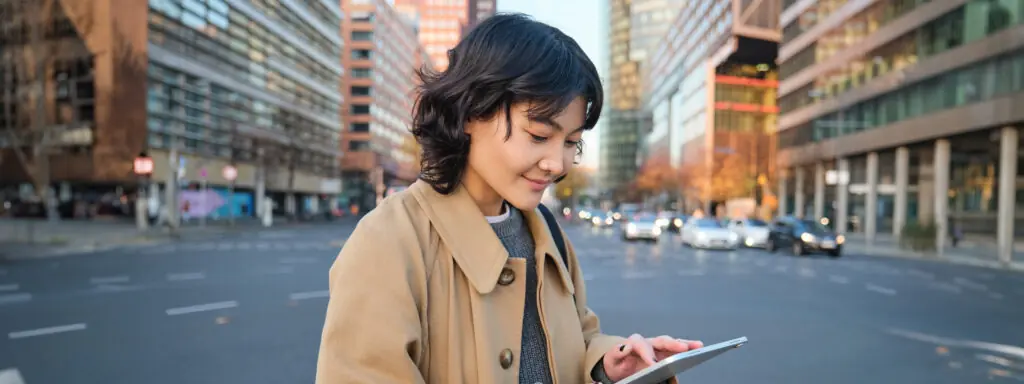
[498,0,608,169]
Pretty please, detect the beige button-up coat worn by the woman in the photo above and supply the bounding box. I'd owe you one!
[316,181,625,384]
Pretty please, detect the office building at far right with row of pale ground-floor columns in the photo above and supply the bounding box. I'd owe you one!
[778,0,1024,261]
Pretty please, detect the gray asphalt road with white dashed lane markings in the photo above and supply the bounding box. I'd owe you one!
[0,218,1024,384]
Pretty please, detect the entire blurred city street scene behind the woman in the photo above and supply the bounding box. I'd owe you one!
[0,0,1024,384]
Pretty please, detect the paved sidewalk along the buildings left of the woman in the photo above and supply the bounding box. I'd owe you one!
[0,217,354,261]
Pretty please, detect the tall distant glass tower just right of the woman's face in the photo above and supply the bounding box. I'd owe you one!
[600,0,684,200]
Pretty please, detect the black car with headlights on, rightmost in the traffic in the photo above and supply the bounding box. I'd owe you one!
[765,217,846,257]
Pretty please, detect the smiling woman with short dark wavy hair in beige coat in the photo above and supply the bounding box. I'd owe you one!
[316,14,701,384]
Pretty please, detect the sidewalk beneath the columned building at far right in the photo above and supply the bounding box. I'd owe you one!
[845,233,1024,271]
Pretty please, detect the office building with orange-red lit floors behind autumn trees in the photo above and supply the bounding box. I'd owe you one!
[643,0,780,214]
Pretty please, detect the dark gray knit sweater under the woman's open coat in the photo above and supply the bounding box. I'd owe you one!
[490,206,551,384]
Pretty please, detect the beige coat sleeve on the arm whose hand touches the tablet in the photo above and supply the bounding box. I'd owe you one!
[562,228,626,379]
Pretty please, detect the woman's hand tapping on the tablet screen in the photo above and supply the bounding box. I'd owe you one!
[604,334,703,381]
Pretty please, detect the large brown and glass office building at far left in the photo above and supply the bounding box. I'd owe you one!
[0,0,344,216]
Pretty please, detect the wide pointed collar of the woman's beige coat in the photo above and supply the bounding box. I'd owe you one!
[409,180,574,294]
